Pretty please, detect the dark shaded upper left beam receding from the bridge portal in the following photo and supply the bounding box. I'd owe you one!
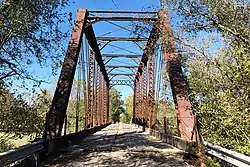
[84,21,109,85]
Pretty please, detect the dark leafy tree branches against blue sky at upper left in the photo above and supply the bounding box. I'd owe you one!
[0,0,67,85]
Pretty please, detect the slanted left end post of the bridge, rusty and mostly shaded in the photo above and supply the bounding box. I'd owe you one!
[43,9,87,140]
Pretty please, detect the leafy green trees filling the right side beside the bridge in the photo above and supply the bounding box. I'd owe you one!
[163,0,250,154]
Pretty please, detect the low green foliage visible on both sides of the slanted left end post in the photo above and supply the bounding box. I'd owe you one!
[0,82,88,151]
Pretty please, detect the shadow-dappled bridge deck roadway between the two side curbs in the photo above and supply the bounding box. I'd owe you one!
[43,123,192,167]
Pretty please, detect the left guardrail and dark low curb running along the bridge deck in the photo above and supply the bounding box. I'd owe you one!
[0,123,110,167]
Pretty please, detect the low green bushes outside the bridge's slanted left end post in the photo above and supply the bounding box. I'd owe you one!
[0,87,47,151]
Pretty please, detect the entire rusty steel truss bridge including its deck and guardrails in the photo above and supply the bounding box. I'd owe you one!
[0,9,250,167]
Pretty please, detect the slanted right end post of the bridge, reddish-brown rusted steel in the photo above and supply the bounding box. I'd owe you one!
[159,11,197,140]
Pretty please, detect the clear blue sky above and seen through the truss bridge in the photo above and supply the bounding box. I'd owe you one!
[27,0,159,99]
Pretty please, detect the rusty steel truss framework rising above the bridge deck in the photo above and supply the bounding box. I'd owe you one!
[43,9,196,141]
